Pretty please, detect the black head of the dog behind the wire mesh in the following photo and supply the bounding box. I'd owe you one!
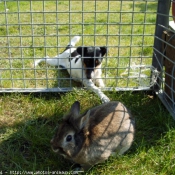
[77,46,107,79]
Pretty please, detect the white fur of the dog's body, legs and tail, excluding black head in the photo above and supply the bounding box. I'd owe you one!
[34,36,110,103]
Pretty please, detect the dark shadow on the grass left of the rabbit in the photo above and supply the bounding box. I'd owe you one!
[0,116,71,174]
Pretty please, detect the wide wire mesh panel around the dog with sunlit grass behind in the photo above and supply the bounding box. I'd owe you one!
[0,0,157,92]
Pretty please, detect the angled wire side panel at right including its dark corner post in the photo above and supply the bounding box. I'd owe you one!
[152,0,175,119]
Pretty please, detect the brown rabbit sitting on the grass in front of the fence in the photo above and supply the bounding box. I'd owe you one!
[51,101,135,170]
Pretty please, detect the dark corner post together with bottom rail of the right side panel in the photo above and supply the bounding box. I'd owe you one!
[151,0,175,119]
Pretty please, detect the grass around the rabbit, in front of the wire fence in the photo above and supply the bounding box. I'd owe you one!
[0,90,175,175]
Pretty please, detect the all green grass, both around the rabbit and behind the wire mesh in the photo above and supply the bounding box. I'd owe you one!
[0,1,175,175]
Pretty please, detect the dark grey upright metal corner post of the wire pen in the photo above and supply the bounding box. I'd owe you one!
[151,0,171,92]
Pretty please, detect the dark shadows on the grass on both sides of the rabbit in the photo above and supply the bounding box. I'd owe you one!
[0,92,175,174]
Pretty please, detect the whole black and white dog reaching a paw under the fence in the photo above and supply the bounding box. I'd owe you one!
[34,36,110,102]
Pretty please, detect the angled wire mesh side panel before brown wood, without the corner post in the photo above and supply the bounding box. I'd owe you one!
[157,26,175,119]
